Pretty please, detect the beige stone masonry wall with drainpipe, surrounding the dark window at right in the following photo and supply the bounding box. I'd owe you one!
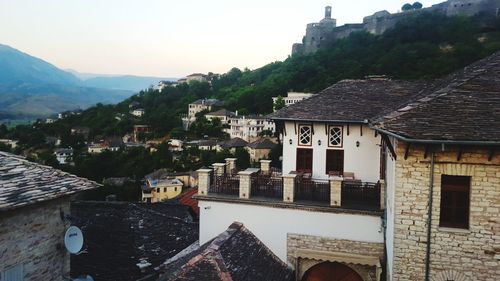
[392,144,500,281]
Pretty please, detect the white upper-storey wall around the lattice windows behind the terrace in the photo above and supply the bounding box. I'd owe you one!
[283,122,380,182]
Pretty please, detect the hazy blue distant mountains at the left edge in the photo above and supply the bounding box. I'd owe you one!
[0,44,175,120]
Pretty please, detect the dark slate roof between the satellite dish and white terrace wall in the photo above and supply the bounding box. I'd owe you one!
[71,201,198,281]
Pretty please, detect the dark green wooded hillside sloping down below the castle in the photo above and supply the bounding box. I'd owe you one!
[4,10,500,142]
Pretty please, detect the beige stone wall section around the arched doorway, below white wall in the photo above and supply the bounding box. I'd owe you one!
[287,233,384,281]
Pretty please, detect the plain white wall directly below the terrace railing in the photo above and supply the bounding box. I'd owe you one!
[198,200,384,261]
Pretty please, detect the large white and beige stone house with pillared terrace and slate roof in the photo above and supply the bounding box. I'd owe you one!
[196,53,500,280]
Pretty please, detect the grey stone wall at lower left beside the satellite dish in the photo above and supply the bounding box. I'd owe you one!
[0,199,70,281]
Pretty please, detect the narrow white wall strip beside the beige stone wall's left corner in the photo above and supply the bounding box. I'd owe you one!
[385,137,396,281]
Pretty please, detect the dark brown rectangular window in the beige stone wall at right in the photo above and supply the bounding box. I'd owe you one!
[439,175,470,228]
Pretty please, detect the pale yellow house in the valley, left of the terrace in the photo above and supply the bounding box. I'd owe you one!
[142,170,184,203]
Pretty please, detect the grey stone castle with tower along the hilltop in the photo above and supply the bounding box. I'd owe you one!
[292,0,500,55]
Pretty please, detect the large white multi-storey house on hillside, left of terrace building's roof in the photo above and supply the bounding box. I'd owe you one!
[227,115,275,142]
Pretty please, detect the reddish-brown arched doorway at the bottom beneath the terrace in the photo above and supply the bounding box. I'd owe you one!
[302,262,363,281]
